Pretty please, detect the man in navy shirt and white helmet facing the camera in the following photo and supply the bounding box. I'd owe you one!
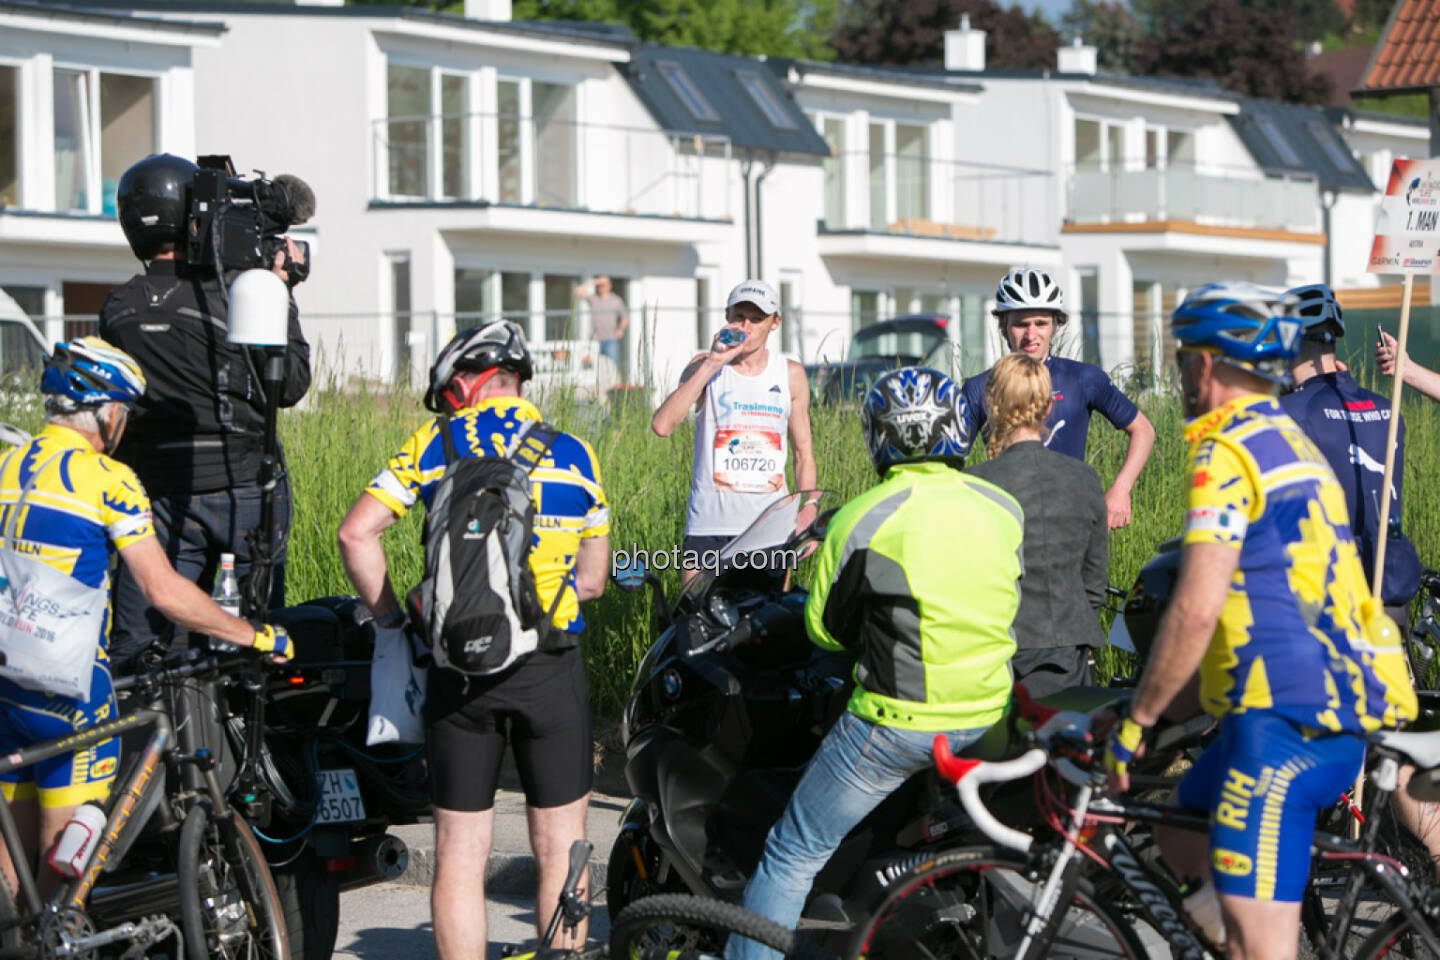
[962,268,1155,530]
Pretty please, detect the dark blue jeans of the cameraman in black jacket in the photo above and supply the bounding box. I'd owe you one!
[109,478,289,675]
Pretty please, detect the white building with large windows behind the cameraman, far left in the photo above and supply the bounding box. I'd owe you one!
[0,1,225,368]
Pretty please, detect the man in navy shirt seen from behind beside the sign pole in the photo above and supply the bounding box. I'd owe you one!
[1280,284,1420,626]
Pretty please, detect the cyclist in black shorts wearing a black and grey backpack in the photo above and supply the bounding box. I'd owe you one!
[338,321,611,960]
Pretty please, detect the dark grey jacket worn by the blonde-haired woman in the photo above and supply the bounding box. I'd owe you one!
[965,440,1109,651]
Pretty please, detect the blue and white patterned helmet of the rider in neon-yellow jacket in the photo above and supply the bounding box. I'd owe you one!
[860,367,971,474]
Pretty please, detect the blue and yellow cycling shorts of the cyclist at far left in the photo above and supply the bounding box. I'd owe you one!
[0,662,120,809]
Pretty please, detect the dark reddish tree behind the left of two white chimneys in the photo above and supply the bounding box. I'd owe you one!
[831,0,1060,69]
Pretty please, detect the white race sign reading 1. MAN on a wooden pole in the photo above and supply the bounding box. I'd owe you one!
[1369,160,1440,273]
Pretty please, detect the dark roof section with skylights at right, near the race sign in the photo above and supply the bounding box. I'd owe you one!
[1225,99,1375,193]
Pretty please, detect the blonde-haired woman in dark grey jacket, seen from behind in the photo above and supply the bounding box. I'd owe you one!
[966,353,1107,697]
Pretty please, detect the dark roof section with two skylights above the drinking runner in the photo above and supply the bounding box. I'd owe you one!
[616,43,829,157]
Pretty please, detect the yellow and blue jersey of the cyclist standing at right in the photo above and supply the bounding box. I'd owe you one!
[1184,394,1417,733]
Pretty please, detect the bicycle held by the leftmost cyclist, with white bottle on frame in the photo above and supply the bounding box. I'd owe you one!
[0,651,289,960]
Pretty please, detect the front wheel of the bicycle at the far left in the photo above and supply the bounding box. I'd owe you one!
[176,806,289,960]
